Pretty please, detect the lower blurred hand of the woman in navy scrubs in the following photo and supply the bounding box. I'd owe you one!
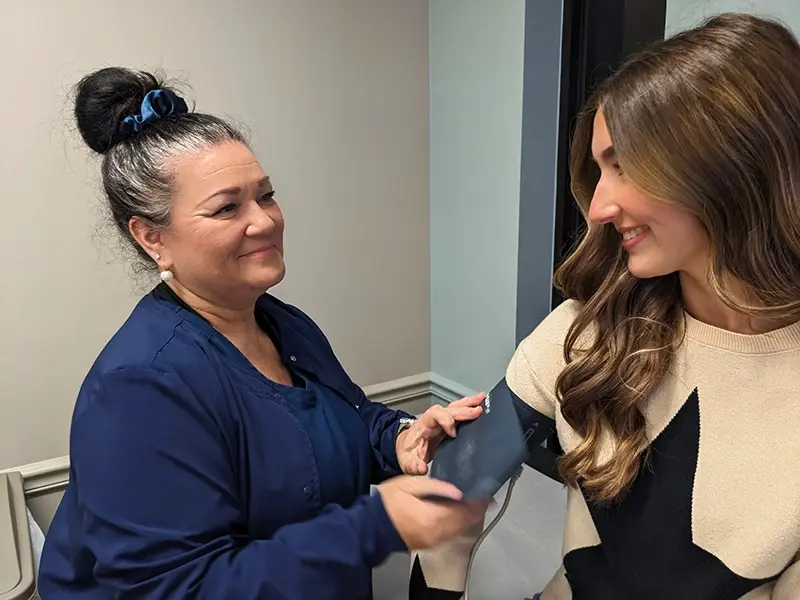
[378,475,491,550]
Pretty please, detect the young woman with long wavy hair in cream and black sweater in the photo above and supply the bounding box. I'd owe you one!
[411,14,800,600]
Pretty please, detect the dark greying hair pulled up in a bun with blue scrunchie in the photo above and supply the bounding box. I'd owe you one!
[75,67,248,261]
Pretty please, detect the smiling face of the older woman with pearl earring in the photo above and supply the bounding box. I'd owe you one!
[131,142,285,305]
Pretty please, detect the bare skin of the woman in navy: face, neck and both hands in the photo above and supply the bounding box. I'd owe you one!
[129,142,488,548]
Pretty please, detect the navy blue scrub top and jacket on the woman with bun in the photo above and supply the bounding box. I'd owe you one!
[38,285,409,600]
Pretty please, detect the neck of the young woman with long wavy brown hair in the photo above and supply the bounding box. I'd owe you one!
[680,272,789,335]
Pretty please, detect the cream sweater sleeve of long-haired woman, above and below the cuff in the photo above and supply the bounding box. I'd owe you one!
[409,302,576,600]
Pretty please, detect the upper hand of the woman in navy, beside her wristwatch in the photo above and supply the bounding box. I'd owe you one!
[396,392,486,475]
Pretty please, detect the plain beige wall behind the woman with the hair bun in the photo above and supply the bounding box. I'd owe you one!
[0,0,430,468]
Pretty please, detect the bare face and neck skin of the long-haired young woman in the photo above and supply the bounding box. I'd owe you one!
[589,110,788,334]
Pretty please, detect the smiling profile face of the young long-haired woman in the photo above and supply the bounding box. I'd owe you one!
[589,110,707,279]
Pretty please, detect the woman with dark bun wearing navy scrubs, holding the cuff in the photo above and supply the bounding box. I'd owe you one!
[39,68,486,600]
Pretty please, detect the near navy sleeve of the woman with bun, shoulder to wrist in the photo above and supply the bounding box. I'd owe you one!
[65,368,406,600]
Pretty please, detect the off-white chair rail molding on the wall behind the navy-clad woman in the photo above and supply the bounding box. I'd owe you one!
[2,373,474,498]
